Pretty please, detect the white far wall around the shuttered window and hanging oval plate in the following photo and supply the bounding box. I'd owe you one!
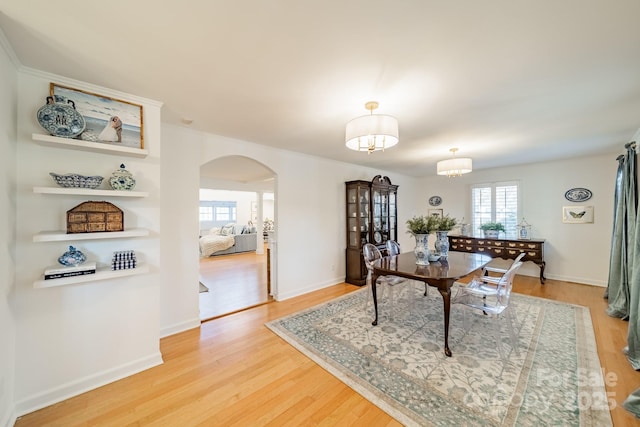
[421,152,625,286]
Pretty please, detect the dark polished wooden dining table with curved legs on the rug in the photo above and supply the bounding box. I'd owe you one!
[371,251,491,357]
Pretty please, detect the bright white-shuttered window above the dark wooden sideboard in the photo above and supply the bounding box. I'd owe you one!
[471,181,519,239]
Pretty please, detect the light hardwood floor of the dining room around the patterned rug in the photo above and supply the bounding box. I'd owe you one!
[16,276,640,427]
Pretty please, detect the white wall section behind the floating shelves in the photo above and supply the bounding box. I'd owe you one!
[14,69,162,414]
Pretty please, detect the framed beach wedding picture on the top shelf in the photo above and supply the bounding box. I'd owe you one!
[49,83,144,149]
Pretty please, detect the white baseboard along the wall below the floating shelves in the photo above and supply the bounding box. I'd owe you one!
[14,351,163,417]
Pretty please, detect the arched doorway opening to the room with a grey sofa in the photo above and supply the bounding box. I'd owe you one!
[199,156,277,321]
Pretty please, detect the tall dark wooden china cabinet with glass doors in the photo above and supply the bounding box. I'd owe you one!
[345,175,398,286]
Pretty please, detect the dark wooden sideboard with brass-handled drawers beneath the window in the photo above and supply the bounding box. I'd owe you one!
[448,236,545,284]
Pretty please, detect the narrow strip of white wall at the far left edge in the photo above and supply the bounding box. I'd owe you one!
[0,26,18,426]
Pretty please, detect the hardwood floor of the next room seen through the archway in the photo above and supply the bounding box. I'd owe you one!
[199,245,271,321]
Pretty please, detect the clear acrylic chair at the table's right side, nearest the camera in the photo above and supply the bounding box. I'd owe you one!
[451,261,522,360]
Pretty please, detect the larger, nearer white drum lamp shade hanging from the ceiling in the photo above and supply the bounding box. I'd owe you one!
[345,114,398,152]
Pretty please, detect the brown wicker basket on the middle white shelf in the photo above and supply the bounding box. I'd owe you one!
[67,201,124,234]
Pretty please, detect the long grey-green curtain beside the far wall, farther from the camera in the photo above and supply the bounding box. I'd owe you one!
[605,143,637,319]
